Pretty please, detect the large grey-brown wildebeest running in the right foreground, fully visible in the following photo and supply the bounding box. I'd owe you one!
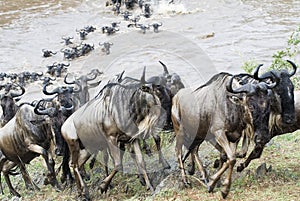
[172,73,276,198]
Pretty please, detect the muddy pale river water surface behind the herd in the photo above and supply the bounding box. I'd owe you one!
[0,0,300,88]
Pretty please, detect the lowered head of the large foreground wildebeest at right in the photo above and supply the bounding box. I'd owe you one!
[227,74,278,143]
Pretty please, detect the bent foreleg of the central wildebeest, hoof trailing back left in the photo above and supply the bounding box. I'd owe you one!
[100,136,122,193]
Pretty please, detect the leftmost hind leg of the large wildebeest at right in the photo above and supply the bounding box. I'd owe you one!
[174,126,189,186]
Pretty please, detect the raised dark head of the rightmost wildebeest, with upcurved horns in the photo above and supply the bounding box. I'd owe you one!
[254,60,297,124]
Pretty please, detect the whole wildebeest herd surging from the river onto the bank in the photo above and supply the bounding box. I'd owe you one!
[0,0,300,200]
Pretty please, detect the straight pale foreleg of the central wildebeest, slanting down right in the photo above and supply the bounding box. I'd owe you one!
[132,139,154,192]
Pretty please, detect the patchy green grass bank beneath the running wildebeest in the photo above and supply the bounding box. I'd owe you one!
[0,132,300,201]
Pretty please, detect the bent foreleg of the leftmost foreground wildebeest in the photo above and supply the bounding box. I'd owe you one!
[28,144,60,188]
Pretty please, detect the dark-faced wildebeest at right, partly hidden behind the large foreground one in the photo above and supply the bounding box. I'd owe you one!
[237,61,298,171]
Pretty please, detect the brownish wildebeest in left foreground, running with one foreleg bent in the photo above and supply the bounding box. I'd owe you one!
[0,100,58,197]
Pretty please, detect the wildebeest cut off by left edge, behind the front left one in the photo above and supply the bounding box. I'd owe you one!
[0,83,25,127]
